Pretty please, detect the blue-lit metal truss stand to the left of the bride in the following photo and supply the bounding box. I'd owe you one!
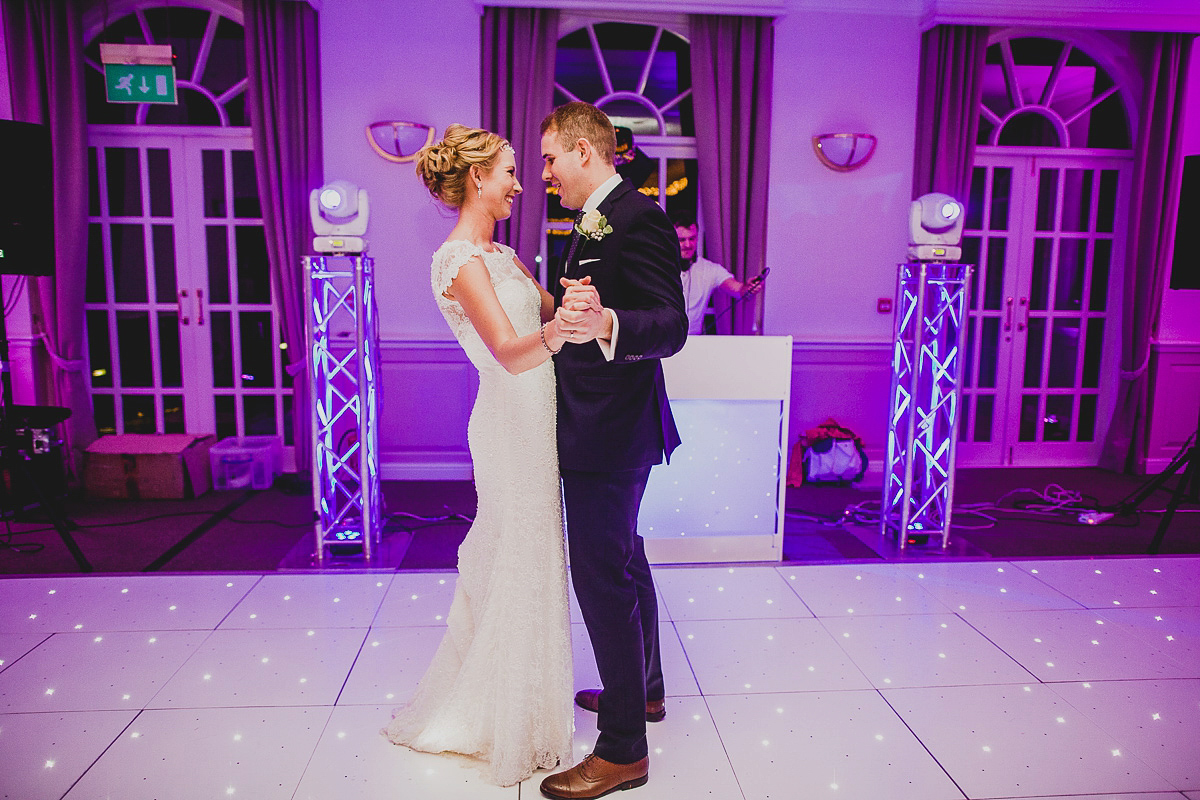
[304,255,383,564]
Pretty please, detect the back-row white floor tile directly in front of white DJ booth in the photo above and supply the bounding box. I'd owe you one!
[654,566,812,622]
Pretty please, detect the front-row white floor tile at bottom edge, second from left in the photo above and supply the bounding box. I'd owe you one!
[66,708,330,800]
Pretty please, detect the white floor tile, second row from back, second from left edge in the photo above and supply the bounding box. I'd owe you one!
[149,627,367,709]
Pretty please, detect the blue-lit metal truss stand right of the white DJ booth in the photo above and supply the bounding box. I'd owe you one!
[880,261,972,551]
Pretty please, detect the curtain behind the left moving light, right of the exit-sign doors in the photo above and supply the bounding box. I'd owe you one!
[242,0,323,470]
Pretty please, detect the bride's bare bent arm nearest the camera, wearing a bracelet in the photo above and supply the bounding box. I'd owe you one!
[446,255,566,374]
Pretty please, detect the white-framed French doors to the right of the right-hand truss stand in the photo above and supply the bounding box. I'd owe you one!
[956,150,1132,467]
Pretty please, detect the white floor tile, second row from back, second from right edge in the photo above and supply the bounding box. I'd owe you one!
[970,609,1200,681]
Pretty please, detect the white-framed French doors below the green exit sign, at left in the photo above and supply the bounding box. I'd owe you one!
[85,126,292,446]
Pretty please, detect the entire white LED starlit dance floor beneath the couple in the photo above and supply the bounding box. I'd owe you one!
[0,557,1200,800]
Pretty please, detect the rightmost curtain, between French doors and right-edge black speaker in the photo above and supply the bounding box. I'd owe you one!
[1100,34,1193,473]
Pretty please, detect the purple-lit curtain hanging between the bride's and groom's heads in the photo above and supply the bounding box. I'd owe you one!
[480,6,558,272]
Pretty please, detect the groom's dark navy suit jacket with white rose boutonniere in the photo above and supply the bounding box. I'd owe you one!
[554,181,688,471]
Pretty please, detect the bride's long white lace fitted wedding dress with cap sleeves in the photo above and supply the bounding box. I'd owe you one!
[383,241,574,786]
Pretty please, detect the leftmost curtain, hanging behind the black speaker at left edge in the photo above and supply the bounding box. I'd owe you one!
[4,0,96,480]
